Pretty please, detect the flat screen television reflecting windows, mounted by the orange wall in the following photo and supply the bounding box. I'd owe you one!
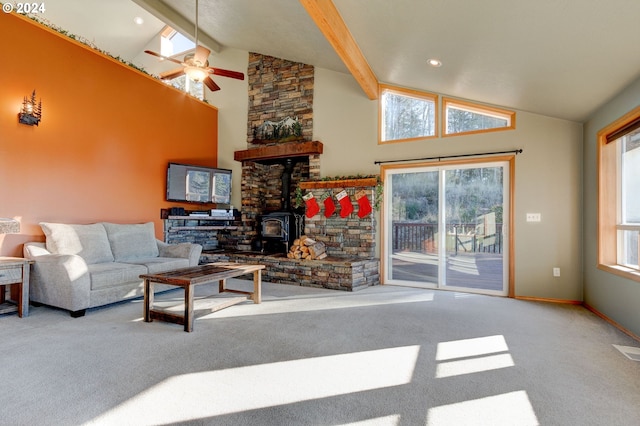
[167,163,231,204]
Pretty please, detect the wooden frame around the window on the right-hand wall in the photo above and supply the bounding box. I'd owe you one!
[597,106,640,282]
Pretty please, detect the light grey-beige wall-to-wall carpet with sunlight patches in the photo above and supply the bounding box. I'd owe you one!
[0,280,640,426]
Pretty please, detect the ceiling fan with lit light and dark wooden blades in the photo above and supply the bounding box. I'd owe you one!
[144,0,244,92]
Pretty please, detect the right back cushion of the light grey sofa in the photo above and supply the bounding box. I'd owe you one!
[103,222,158,262]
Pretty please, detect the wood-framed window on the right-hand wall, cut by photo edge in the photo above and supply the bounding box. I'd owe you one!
[598,107,640,281]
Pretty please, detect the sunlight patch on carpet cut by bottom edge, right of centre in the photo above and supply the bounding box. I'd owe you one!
[426,391,540,426]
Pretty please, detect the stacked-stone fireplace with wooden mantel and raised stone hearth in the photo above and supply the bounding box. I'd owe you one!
[195,53,380,291]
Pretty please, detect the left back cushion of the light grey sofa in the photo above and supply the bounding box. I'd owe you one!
[40,222,113,264]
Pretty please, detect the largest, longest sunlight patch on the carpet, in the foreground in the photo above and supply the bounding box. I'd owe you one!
[91,345,420,425]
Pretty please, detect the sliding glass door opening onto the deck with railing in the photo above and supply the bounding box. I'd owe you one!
[383,161,510,295]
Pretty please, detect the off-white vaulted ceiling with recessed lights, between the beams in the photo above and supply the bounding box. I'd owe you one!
[36,0,640,121]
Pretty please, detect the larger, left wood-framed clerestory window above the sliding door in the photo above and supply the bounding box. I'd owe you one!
[379,85,438,143]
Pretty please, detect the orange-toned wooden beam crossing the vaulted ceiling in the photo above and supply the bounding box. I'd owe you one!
[300,0,378,100]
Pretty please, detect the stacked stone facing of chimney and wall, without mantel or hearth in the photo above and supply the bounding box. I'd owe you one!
[230,53,376,258]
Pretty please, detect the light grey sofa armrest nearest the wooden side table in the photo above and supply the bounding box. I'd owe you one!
[23,243,91,312]
